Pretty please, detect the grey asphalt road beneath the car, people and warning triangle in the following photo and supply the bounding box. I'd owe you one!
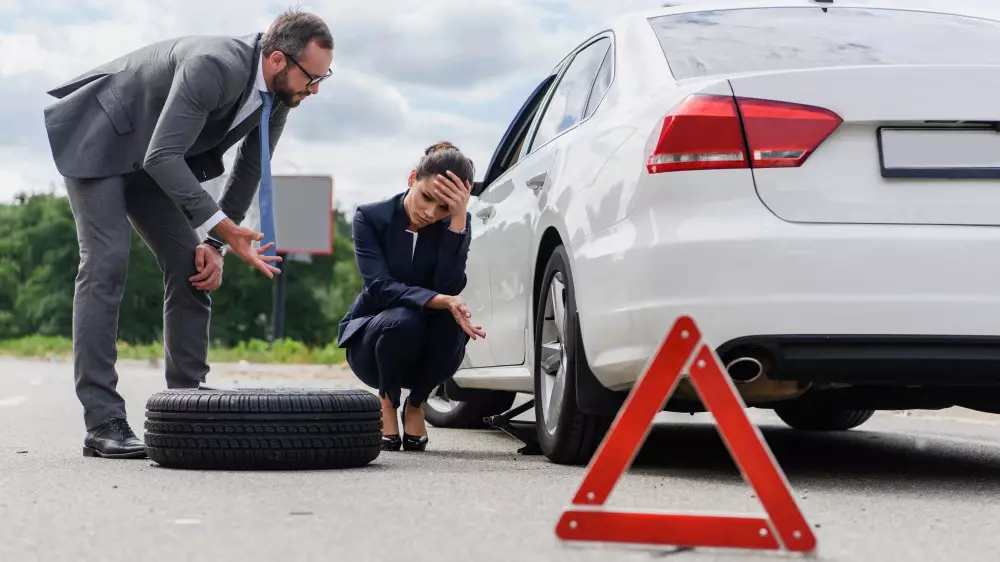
[0,358,1000,562]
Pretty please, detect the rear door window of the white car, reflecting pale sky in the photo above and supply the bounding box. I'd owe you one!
[529,37,611,152]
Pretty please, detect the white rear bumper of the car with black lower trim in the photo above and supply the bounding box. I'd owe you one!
[572,171,1000,389]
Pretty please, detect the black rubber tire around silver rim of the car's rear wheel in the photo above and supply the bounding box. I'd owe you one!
[533,246,612,465]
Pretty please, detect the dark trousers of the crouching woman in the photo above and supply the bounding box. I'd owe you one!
[347,307,469,408]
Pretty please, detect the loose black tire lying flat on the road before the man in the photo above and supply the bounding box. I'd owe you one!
[144,388,382,470]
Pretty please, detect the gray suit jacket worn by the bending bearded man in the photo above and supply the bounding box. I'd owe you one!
[45,33,288,227]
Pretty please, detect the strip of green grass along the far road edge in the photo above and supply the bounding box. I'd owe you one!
[0,336,346,365]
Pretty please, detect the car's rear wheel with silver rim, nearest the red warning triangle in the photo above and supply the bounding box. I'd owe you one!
[534,246,611,465]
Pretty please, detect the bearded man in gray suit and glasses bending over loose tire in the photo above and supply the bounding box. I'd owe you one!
[45,11,333,458]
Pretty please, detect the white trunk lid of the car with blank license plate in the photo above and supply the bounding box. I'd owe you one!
[730,66,1000,225]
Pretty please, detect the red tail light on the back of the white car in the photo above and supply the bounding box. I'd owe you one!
[646,94,842,174]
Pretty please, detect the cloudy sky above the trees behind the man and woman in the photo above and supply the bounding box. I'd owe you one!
[0,0,997,214]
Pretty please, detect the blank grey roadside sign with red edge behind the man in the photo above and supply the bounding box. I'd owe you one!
[274,176,333,255]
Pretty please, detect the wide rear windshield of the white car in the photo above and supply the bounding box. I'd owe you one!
[649,7,1000,80]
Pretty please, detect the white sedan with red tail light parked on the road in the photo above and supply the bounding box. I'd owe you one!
[427,0,1000,463]
